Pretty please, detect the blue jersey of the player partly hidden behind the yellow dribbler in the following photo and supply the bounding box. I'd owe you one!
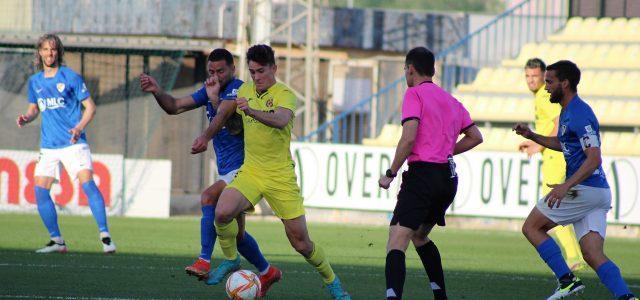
[191,78,244,175]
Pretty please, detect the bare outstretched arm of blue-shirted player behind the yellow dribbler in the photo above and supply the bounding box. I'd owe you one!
[140,74,199,115]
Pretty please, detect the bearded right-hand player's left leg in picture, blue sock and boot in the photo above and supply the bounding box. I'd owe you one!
[522,207,584,299]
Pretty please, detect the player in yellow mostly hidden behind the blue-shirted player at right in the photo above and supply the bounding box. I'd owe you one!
[519,58,585,271]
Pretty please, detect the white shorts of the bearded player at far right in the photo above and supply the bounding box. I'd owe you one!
[536,185,611,240]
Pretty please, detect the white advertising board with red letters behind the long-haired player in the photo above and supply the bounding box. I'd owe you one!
[0,150,171,217]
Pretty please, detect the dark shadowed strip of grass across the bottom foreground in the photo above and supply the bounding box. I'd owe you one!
[0,248,640,299]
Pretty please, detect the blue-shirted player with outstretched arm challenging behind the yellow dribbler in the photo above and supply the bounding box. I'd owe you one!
[140,49,282,296]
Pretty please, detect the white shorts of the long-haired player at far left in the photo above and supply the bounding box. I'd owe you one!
[34,144,93,180]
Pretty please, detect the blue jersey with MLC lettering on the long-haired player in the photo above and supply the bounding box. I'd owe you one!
[28,66,89,149]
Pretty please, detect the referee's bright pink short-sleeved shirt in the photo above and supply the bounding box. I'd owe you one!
[402,81,474,163]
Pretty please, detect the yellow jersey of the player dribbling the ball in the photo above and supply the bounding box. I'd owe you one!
[238,81,296,171]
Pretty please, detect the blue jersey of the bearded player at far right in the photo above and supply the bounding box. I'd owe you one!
[558,95,609,188]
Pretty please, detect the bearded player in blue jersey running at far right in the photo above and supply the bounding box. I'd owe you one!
[513,60,637,300]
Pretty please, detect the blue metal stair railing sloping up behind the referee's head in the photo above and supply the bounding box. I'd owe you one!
[300,0,569,144]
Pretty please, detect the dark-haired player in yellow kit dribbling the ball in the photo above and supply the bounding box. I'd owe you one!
[215,45,351,300]
